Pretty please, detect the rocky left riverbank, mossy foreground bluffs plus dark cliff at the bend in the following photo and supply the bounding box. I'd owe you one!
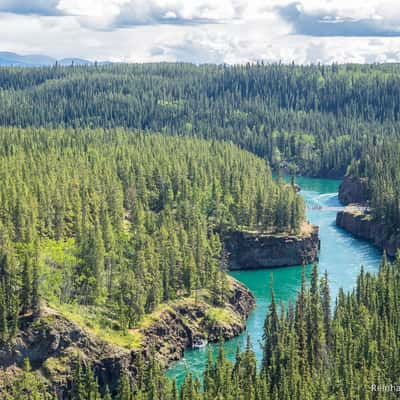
[0,216,320,395]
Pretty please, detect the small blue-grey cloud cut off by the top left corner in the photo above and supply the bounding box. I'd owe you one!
[0,0,62,16]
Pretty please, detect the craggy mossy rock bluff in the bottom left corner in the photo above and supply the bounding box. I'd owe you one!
[0,309,137,399]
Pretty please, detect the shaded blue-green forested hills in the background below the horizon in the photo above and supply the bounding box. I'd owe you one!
[0,64,400,177]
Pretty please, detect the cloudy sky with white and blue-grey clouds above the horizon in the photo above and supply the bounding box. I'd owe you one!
[0,0,400,64]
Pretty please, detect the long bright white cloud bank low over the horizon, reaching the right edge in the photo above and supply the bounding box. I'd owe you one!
[151,27,400,64]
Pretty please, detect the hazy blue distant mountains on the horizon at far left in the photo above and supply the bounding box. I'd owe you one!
[0,51,100,67]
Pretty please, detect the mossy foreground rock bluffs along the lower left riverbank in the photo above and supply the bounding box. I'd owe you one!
[0,278,255,399]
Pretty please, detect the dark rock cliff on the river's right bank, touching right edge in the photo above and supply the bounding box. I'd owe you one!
[336,207,400,256]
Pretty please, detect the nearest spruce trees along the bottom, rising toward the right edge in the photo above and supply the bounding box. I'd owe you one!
[10,260,400,400]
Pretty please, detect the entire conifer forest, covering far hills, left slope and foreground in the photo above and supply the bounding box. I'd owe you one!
[0,64,400,400]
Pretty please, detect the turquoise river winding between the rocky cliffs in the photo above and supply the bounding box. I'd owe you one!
[167,178,382,385]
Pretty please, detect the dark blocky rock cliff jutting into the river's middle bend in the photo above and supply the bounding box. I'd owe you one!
[224,226,320,270]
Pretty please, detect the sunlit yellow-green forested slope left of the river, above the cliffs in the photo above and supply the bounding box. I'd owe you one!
[0,128,304,342]
